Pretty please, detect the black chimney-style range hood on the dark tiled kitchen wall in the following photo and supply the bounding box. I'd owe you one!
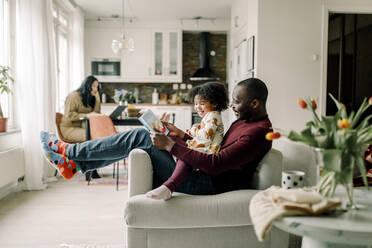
[190,32,220,81]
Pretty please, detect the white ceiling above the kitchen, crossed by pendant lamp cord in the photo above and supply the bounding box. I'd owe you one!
[72,0,234,20]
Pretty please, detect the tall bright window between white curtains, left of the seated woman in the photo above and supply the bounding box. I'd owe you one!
[53,1,70,112]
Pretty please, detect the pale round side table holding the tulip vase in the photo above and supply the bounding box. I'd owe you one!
[273,188,372,248]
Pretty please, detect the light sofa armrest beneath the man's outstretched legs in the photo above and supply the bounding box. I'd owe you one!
[128,149,153,197]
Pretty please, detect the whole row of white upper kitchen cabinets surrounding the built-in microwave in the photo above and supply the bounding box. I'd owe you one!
[85,27,182,82]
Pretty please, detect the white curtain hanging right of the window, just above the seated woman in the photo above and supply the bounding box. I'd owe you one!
[69,7,85,92]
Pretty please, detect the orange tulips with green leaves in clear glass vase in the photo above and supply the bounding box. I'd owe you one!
[266,95,372,208]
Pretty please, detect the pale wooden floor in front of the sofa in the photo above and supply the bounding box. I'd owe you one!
[0,166,127,248]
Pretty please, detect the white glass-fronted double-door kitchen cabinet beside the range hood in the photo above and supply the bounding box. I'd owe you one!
[151,30,182,82]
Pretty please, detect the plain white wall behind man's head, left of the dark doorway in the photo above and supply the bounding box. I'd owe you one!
[256,0,322,130]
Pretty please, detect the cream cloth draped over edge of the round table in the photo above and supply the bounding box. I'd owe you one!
[249,186,341,241]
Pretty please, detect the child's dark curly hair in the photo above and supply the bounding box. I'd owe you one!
[189,82,229,112]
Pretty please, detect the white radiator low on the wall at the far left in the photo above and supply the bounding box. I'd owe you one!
[0,147,25,188]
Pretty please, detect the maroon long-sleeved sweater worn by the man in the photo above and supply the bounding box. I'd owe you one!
[171,116,272,193]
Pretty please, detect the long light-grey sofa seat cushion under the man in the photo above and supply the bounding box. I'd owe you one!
[125,190,258,228]
